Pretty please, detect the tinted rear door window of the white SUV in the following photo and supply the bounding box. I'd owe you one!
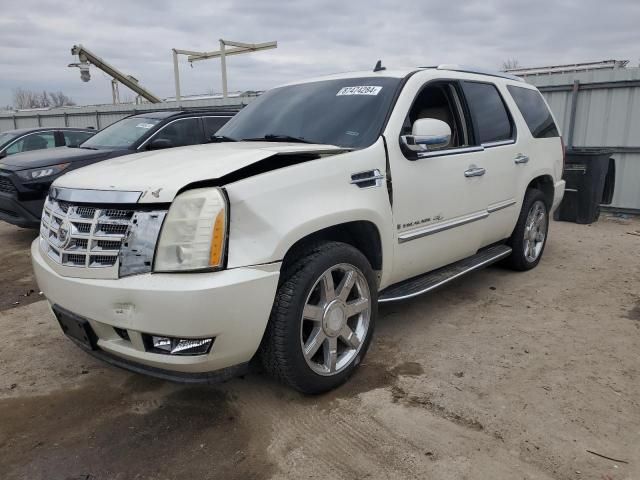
[462,82,513,143]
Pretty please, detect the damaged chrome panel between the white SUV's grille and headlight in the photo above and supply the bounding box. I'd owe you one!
[119,210,167,277]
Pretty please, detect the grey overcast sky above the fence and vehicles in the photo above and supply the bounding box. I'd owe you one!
[0,0,640,105]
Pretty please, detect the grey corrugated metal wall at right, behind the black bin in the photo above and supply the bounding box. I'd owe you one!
[525,68,640,213]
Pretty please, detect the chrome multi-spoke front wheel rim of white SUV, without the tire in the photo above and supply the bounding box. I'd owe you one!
[300,263,371,376]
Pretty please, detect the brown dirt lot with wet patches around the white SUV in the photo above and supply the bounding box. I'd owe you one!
[0,218,640,480]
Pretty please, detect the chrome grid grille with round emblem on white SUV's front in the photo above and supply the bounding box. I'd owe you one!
[40,199,135,268]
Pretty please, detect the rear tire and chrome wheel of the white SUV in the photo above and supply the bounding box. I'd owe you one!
[505,188,549,271]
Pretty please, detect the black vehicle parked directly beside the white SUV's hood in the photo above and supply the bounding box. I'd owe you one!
[0,110,237,228]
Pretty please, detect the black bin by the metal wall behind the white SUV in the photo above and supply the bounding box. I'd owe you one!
[554,147,616,224]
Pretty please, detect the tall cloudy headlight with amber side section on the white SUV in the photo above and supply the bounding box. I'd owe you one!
[154,188,228,272]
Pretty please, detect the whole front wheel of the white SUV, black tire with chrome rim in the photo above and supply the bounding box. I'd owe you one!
[260,242,378,394]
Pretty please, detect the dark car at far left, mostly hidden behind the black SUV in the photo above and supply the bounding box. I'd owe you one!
[0,127,96,158]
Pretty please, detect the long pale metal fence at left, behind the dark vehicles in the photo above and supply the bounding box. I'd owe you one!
[0,94,257,132]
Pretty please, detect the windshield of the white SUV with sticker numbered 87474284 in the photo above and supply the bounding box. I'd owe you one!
[217,77,400,148]
